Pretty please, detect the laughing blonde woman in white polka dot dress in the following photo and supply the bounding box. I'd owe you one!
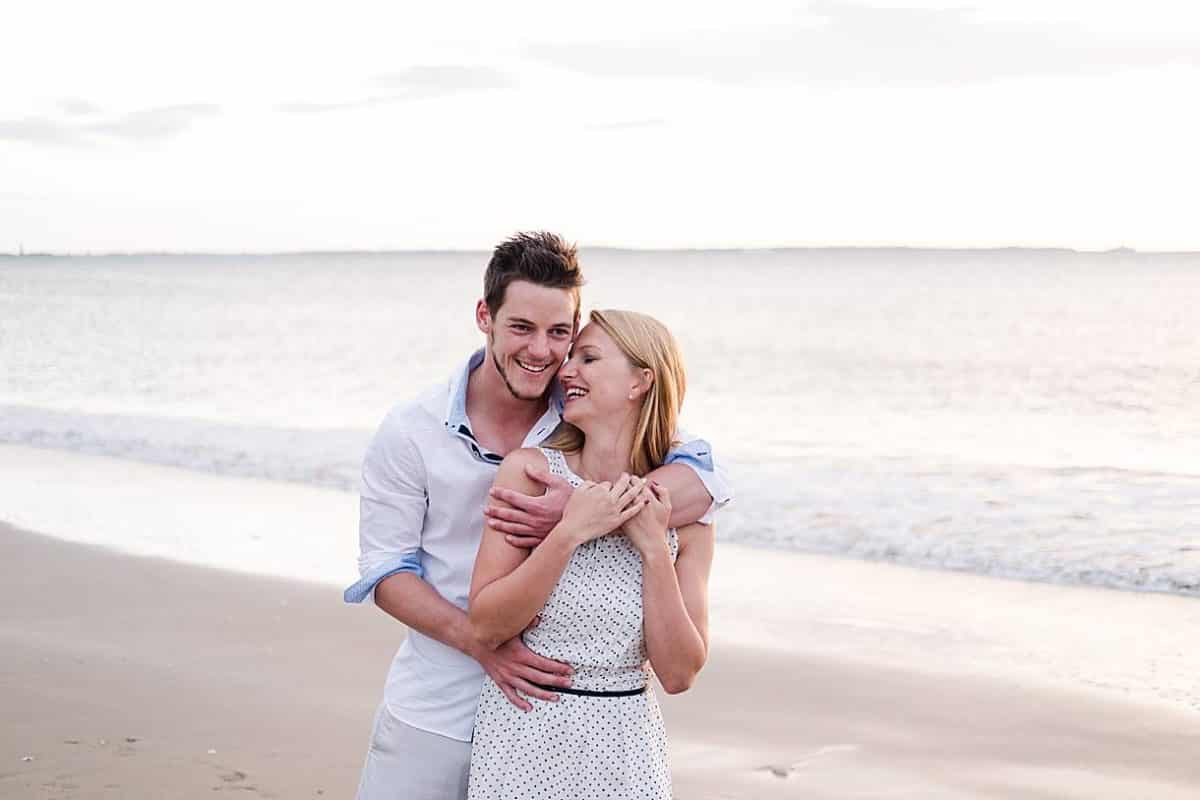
[468,311,713,800]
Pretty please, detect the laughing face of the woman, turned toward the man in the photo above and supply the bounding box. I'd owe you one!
[558,323,641,426]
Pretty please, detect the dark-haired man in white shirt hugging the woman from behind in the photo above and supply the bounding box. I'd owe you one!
[346,233,728,800]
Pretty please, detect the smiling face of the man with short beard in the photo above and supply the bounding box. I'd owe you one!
[475,281,575,401]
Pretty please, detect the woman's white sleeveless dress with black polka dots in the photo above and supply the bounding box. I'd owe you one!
[467,449,679,800]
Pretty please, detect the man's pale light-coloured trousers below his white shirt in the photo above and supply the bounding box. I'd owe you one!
[356,703,470,800]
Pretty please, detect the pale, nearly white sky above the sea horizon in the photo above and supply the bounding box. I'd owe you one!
[0,0,1200,252]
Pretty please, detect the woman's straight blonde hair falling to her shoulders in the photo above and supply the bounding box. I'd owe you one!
[545,308,688,475]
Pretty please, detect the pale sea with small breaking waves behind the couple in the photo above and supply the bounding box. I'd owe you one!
[0,249,1200,595]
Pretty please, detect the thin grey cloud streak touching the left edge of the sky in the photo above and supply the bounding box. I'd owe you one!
[0,101,221,146]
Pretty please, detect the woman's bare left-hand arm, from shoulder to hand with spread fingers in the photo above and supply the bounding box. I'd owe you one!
[467,450,657,649]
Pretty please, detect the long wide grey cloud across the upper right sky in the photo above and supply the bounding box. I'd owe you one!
[529,1,1200,86]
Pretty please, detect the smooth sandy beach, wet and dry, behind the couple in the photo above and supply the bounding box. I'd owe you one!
[0,510,1200,799]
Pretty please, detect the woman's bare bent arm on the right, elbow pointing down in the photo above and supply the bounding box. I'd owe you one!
[642,524,713,694]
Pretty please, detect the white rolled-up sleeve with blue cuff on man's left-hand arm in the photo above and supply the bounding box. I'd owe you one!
[344,417,427,603]
